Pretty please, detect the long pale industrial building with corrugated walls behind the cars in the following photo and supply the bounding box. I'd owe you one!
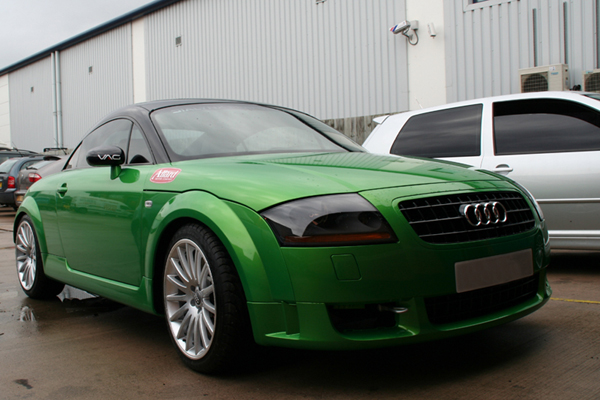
[0,0,600,151]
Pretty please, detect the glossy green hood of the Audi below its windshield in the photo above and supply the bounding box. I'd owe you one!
[161,153,498,211]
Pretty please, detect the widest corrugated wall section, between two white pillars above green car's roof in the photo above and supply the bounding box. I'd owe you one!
[145,0,408,119]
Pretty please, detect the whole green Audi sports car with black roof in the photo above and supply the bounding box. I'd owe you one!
[14,100,551,372]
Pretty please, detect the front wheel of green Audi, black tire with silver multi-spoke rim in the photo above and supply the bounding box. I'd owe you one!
[163,223,253,373]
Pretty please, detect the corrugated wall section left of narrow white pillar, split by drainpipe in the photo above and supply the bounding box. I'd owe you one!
[9,24,133,151]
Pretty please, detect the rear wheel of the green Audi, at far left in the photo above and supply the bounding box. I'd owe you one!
[15,215,65,299]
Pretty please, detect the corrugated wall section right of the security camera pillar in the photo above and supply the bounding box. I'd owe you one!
[444,0,598,102]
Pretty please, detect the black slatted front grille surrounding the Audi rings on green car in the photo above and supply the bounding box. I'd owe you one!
[399,192,535,244]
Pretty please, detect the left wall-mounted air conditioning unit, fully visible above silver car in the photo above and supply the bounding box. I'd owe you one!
[519,64,569,93]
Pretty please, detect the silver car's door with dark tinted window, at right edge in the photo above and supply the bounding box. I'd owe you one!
[482,99,600,248]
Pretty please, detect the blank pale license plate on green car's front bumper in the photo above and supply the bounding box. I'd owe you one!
[454,249,533,293]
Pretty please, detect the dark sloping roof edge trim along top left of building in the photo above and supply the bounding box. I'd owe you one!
[0,0,181,76]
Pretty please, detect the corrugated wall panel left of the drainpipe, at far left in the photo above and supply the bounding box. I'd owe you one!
[8,57,55,150]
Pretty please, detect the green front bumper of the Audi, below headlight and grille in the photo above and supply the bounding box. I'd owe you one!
[243,183,552,349]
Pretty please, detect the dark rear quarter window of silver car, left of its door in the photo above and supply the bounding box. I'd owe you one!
[391,104,483,158]
